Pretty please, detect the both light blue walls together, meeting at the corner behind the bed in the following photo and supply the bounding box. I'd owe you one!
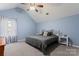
[0,9,79,45]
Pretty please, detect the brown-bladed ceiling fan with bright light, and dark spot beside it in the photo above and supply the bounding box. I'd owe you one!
[21,3,49,15]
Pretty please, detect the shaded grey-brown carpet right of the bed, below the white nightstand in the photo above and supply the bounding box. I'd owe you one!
[51,45,79,56]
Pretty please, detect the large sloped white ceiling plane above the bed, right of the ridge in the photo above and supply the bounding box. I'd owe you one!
[22,3,79,23]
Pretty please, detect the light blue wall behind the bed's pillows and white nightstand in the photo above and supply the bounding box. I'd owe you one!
[37,15,79,45]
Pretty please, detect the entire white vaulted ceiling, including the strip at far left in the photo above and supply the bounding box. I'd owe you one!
[0,3,79,23]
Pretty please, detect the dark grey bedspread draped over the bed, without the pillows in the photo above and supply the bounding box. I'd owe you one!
[25,34,58,55]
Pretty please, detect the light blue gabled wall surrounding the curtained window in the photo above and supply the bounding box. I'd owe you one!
[0,8,36,39]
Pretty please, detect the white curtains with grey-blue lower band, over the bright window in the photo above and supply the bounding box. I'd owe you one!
[0,16,17,44]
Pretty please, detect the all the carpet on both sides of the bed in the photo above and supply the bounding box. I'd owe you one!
[5,42,79,56]
